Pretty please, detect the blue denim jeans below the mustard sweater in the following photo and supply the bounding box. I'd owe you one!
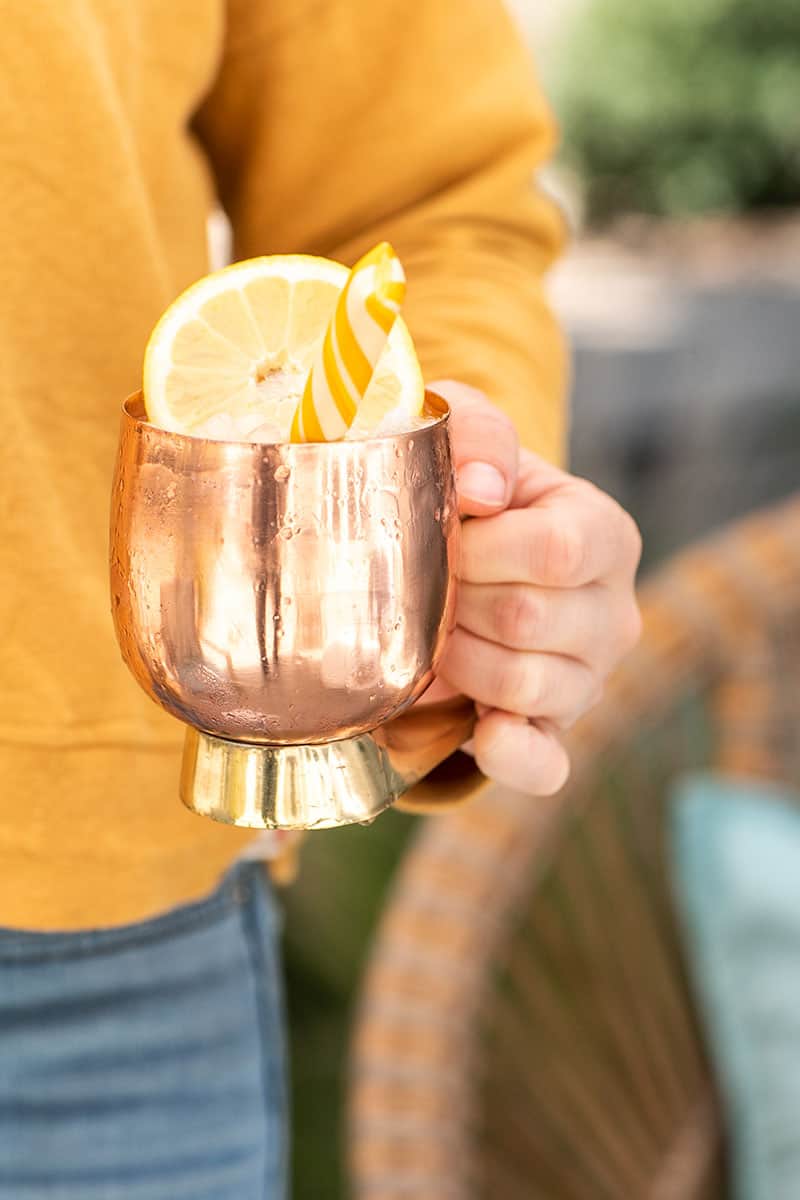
[0,863,288,1200]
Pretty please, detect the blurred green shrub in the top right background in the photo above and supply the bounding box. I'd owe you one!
[555,0,800,220]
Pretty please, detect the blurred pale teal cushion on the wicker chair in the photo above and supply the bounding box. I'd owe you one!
[672,775,800,1200]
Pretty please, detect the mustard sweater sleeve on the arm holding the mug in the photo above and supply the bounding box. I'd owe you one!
[194,0,566,803]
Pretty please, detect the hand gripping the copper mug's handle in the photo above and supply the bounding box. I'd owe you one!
[425,380,642,796]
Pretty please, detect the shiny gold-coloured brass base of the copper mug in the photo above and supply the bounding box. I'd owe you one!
[180,727,408,829]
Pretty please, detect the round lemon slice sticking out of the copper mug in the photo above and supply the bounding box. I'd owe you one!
[143,254,423,438]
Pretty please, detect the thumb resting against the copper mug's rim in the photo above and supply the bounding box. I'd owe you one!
[428,379,519,517]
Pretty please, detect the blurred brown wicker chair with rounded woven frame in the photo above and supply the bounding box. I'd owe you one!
[348,498,800,1200]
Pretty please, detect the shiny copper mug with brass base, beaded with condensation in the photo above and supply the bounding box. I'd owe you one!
[110,392,471,829]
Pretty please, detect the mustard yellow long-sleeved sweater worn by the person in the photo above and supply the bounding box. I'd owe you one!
[0,0,564,929]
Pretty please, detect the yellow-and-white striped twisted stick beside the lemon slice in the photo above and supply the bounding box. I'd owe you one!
[291,241,405,442]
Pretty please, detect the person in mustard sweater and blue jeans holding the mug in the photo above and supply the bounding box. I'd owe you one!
[0,0,639,1200]
